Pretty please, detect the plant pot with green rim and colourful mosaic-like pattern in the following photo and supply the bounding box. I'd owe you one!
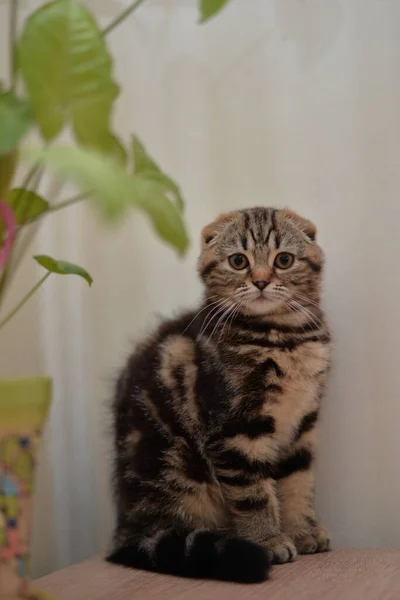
[0,378,51,600]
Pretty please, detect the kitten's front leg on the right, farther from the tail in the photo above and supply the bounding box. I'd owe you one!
[277,427,330,554]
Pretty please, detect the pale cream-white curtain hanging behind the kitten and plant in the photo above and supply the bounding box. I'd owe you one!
[3,0,400,573]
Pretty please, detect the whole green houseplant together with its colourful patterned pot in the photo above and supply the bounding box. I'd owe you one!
[0,0,228,598]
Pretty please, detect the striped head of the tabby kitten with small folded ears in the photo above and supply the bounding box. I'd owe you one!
[199,208,323,315]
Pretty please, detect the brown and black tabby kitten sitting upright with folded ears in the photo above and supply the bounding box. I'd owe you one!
[109,208,330,582]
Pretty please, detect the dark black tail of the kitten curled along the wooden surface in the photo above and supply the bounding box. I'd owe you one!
[107,529,270,583]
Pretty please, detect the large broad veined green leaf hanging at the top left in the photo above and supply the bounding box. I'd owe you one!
[18,0,119,151]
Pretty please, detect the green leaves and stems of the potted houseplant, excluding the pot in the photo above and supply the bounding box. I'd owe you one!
[0,0,228,327]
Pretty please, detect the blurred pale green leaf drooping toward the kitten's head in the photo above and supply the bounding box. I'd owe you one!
[28,147,188,254]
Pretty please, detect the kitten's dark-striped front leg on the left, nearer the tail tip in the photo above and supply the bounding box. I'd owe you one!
[212,436,297,563]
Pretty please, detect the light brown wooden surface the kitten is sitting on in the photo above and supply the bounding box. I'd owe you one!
[34,550,400,600]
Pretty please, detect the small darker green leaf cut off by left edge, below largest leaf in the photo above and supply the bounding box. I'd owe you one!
[0,92,34,156]
